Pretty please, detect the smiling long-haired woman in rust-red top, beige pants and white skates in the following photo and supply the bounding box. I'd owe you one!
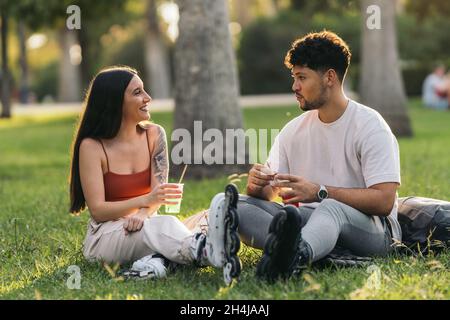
[70,67,240,281]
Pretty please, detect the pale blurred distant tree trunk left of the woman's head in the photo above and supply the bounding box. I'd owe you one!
[58,27,81,102]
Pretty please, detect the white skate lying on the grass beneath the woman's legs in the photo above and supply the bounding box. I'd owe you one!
[121,254,169,280]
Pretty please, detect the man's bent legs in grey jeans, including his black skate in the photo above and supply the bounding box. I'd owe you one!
[237,195,392,280]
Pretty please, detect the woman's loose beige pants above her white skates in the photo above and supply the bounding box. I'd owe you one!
[83,211,207,264]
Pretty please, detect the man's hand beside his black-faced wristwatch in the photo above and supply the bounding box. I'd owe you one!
[273,174,320,204]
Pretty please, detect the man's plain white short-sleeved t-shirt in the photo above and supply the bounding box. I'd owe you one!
[267,100,401,240]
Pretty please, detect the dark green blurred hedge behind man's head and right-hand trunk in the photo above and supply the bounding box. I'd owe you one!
[238,1,450,96]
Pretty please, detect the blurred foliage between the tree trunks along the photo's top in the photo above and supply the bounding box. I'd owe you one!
[2,0,450,102]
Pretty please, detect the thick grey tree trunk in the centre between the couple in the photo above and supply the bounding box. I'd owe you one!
[172,0,248,178]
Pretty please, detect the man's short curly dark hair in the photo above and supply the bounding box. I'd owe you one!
[284,31,352,82]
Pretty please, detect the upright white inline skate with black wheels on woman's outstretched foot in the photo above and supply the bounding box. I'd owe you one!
[204,184,241,285]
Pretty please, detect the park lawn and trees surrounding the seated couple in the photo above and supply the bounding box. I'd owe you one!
[0,0,450,299]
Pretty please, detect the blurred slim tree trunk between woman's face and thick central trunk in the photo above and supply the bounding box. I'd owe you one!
[145,0,171,99]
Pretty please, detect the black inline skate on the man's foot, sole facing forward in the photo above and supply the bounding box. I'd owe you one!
[256,206,312,281]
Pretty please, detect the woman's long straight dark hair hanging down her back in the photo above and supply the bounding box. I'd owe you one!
[70,66,137,214]
